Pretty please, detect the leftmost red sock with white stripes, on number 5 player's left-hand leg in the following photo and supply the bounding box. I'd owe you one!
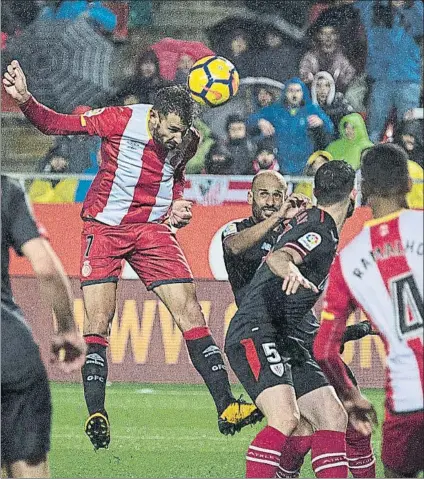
[246,426,287,478]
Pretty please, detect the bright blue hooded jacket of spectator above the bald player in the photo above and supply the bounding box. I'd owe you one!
[247,78,334,175]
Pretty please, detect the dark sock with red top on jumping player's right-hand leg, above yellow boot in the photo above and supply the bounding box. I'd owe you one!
[183,327,235,414]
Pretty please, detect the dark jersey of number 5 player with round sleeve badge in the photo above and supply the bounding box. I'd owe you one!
[226,207,338,344]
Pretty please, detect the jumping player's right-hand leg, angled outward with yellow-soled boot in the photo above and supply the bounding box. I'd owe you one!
[153,282,262,434]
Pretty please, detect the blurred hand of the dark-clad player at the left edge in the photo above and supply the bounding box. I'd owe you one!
[51,329,87,373]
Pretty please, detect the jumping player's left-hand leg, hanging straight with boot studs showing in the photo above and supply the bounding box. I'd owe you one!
[82,282,116,449]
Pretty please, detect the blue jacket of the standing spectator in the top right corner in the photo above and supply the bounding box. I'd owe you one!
[354,0,423,83]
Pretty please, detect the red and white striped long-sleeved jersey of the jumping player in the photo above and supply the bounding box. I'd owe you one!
[20,96,189,225]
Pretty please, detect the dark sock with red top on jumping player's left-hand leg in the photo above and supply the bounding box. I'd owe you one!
[81,334,108,415]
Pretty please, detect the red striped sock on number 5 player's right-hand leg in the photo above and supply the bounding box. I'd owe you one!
[312,431,348,478]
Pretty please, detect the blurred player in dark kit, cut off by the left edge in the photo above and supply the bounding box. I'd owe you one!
[1,175,86,477]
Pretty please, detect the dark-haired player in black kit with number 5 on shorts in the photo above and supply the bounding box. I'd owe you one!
[225,161,354,477]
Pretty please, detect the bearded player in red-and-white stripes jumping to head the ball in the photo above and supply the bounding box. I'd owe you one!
[3,60,258,448]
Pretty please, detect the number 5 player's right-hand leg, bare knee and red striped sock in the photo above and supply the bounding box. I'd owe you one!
[298,386,348,477]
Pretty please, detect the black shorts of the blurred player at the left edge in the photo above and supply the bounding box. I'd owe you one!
[1,371,51,465]
